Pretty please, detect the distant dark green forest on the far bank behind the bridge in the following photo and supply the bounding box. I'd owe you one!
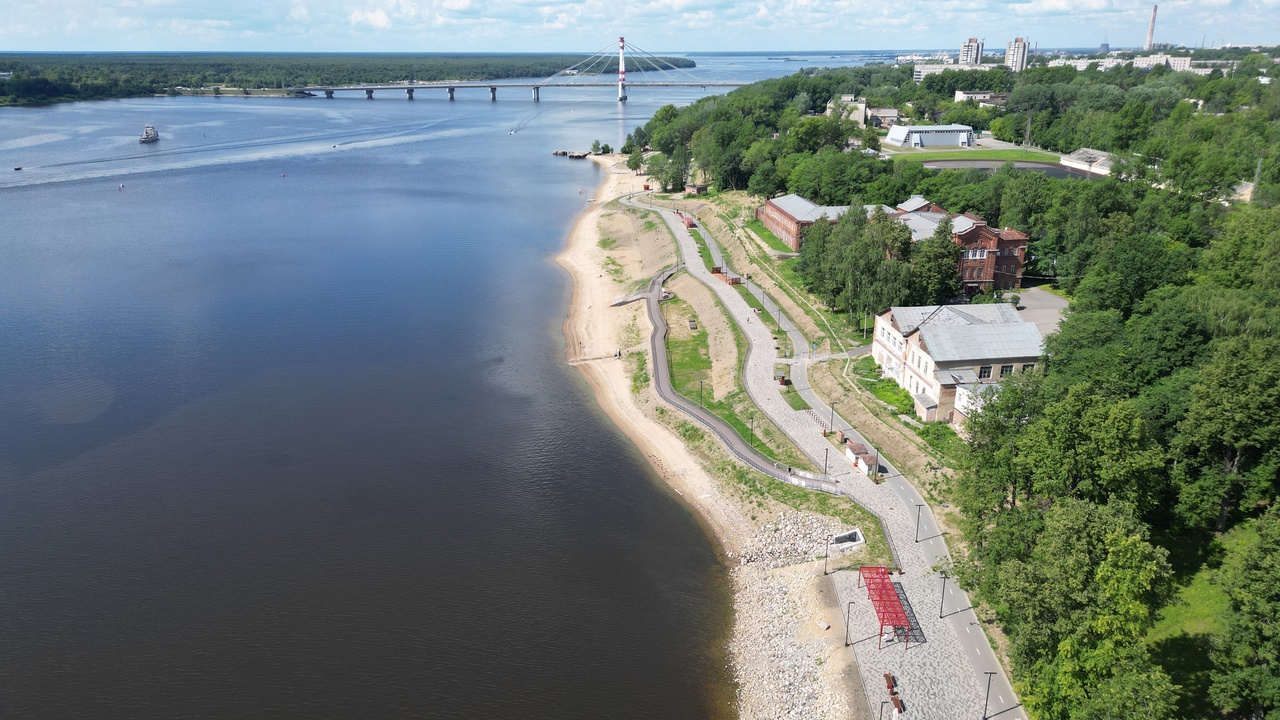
[0,53,694,105]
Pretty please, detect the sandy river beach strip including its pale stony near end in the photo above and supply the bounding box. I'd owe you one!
[557,155,869,719]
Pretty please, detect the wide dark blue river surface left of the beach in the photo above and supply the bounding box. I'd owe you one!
[0,51,880,720]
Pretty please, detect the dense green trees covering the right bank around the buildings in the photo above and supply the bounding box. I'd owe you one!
[623,55,1280,720]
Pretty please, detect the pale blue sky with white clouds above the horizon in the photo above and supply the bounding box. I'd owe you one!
[0,0,1280,53]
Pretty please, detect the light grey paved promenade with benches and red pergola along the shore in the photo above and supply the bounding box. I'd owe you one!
[623,193,1025,720]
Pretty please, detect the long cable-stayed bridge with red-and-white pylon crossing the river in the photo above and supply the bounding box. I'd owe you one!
[291,37,748,102]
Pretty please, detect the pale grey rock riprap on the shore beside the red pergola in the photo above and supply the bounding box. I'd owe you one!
[731,512,849,720]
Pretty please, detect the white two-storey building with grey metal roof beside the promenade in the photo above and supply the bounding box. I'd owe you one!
[872,302,1044,430]
